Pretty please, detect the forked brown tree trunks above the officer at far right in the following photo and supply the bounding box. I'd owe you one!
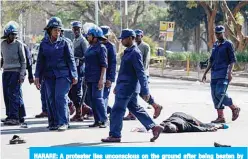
[198,0,248,51]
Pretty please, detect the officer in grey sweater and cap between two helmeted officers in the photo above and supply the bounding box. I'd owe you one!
[69,21,89,121]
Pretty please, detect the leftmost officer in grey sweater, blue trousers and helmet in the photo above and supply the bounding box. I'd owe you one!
[1,21,26,125]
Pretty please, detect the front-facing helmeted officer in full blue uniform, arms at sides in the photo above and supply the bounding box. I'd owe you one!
[35,17,78,131]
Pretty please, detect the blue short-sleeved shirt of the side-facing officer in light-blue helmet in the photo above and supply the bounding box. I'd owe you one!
[84,42,108,82]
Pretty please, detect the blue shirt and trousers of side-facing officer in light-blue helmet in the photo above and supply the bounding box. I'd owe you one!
[85,42,108,123]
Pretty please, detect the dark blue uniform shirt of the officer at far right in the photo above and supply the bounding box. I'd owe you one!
[210,40,236,79]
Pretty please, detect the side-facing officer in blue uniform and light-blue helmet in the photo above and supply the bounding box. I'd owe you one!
[85,27,107,128]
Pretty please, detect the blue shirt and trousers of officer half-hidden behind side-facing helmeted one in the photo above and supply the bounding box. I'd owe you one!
[103,41,116,112]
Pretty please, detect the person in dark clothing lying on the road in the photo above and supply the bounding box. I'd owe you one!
[160,112,228,133]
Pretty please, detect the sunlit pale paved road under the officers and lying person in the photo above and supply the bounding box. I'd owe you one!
[1,78,248,159]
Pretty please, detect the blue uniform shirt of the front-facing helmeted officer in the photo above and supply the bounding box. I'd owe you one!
[35,37,78,78]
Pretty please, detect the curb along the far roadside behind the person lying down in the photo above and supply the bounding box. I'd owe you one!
[150,73,248,87]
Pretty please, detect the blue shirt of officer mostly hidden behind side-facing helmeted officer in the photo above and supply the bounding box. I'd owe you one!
[104,41,116,82]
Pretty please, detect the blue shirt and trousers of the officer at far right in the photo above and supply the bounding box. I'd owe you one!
[210,40,236,109]
